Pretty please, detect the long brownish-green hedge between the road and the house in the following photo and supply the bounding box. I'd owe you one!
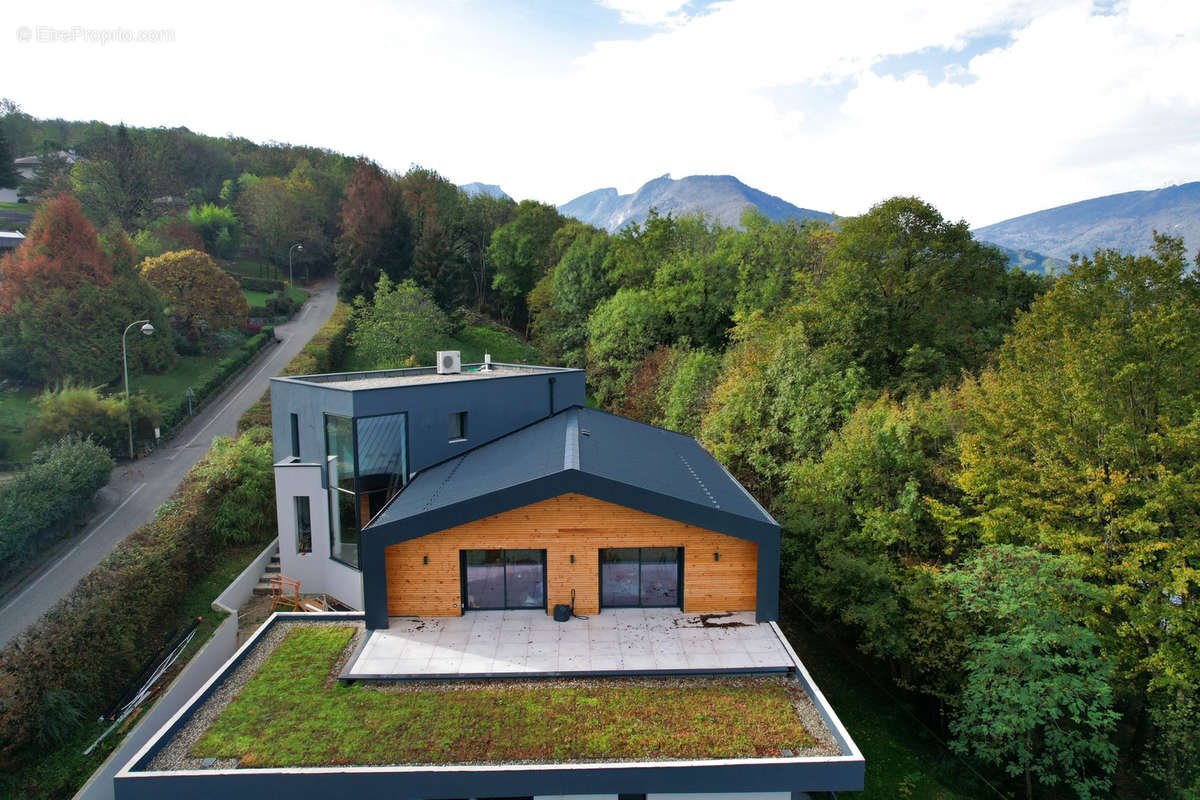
[0,303,349,769]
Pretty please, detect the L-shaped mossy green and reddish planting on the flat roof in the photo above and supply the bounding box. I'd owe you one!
[192,625,814,766]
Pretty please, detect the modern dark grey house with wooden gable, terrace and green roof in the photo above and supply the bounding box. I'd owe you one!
[115,353,864,800]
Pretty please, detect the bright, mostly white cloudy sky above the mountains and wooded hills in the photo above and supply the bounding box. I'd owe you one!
[0,0,1200,227]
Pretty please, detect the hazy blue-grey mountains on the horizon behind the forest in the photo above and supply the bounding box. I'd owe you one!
[460,174,1200,273]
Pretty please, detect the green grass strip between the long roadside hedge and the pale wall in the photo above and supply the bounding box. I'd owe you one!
[0,542,265,799]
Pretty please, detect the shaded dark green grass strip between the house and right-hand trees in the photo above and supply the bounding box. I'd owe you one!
[780,610,1003,800]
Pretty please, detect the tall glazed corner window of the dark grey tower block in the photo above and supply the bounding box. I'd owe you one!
[325,414,408,569]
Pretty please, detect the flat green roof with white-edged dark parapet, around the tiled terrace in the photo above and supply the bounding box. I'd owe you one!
[114,614,864,800]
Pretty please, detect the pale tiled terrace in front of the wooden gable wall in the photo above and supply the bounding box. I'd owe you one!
[341,608,793,679]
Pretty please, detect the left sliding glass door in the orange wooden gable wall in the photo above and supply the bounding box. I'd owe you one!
[461,549,546,610]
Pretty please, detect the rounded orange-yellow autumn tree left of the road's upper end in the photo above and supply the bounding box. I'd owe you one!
[142,249,250,332]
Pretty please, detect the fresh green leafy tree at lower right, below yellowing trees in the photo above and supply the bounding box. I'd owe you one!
[944,546,1120,800]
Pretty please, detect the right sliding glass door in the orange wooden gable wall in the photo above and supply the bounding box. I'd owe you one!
[600,547,683,608]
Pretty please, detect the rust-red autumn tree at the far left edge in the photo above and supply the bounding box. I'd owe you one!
[0,194,113,312]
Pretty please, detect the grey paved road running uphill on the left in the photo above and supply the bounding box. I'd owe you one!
[0,281,337,646]
